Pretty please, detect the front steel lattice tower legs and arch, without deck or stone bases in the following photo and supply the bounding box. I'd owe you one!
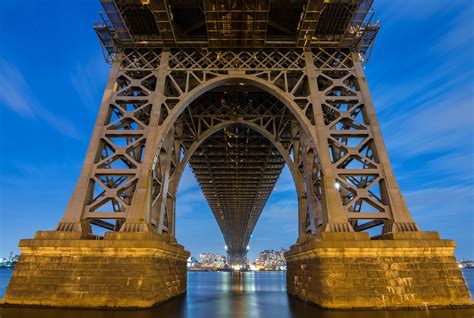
[53,49,417,241]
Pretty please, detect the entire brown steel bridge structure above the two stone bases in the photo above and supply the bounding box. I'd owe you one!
[51,0,418,262]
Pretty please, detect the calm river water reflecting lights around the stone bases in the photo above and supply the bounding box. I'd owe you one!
[0,270,474,318]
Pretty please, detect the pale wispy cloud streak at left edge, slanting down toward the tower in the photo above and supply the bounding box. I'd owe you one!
[0,58,81,139]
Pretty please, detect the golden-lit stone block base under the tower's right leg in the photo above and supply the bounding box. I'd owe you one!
[285,232,472,309]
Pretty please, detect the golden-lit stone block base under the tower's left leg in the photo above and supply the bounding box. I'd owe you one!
[2,232,189,308]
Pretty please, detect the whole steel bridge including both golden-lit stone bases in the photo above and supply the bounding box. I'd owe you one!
[4,0,471,308]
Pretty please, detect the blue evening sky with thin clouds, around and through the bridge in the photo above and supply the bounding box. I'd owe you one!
[0,0,474,259]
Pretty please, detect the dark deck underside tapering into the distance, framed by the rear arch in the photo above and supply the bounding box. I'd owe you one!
[190,126,284,265]
